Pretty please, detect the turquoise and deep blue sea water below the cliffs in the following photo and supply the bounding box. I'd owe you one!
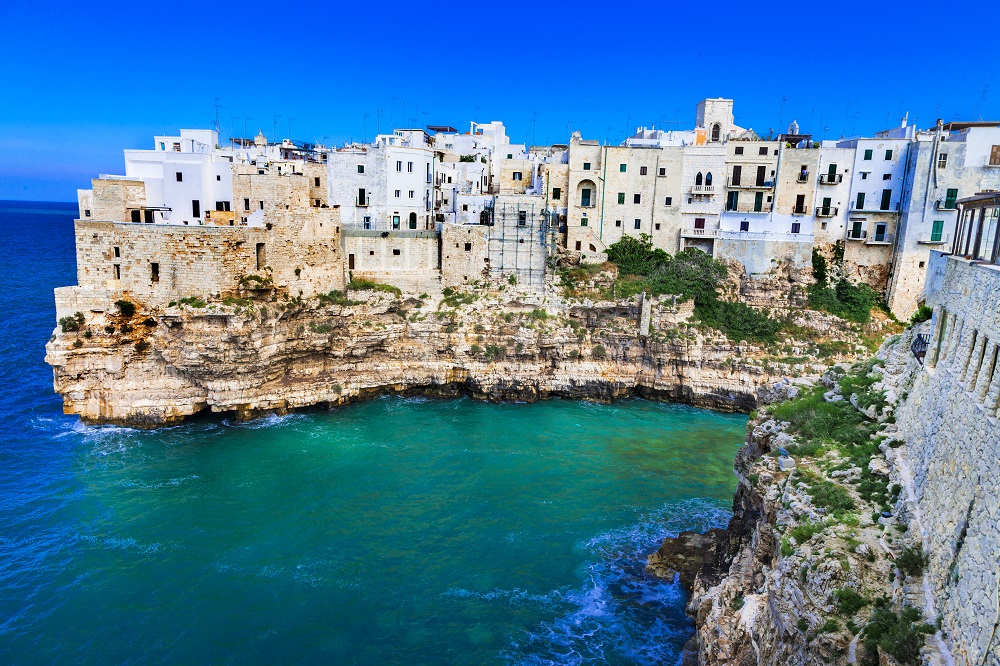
[0,204,746,664]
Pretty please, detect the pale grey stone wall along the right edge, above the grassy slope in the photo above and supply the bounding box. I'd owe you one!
[898,252,1000,665]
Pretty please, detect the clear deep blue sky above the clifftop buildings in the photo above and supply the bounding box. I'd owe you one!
[0,0,1000,201]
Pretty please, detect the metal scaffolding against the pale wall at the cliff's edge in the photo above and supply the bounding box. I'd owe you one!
[483,202,552,288]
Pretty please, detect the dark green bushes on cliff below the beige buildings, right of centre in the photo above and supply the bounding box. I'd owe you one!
[608,234,781,342]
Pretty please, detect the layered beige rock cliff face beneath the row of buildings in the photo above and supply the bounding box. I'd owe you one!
[46,290,788,426]
